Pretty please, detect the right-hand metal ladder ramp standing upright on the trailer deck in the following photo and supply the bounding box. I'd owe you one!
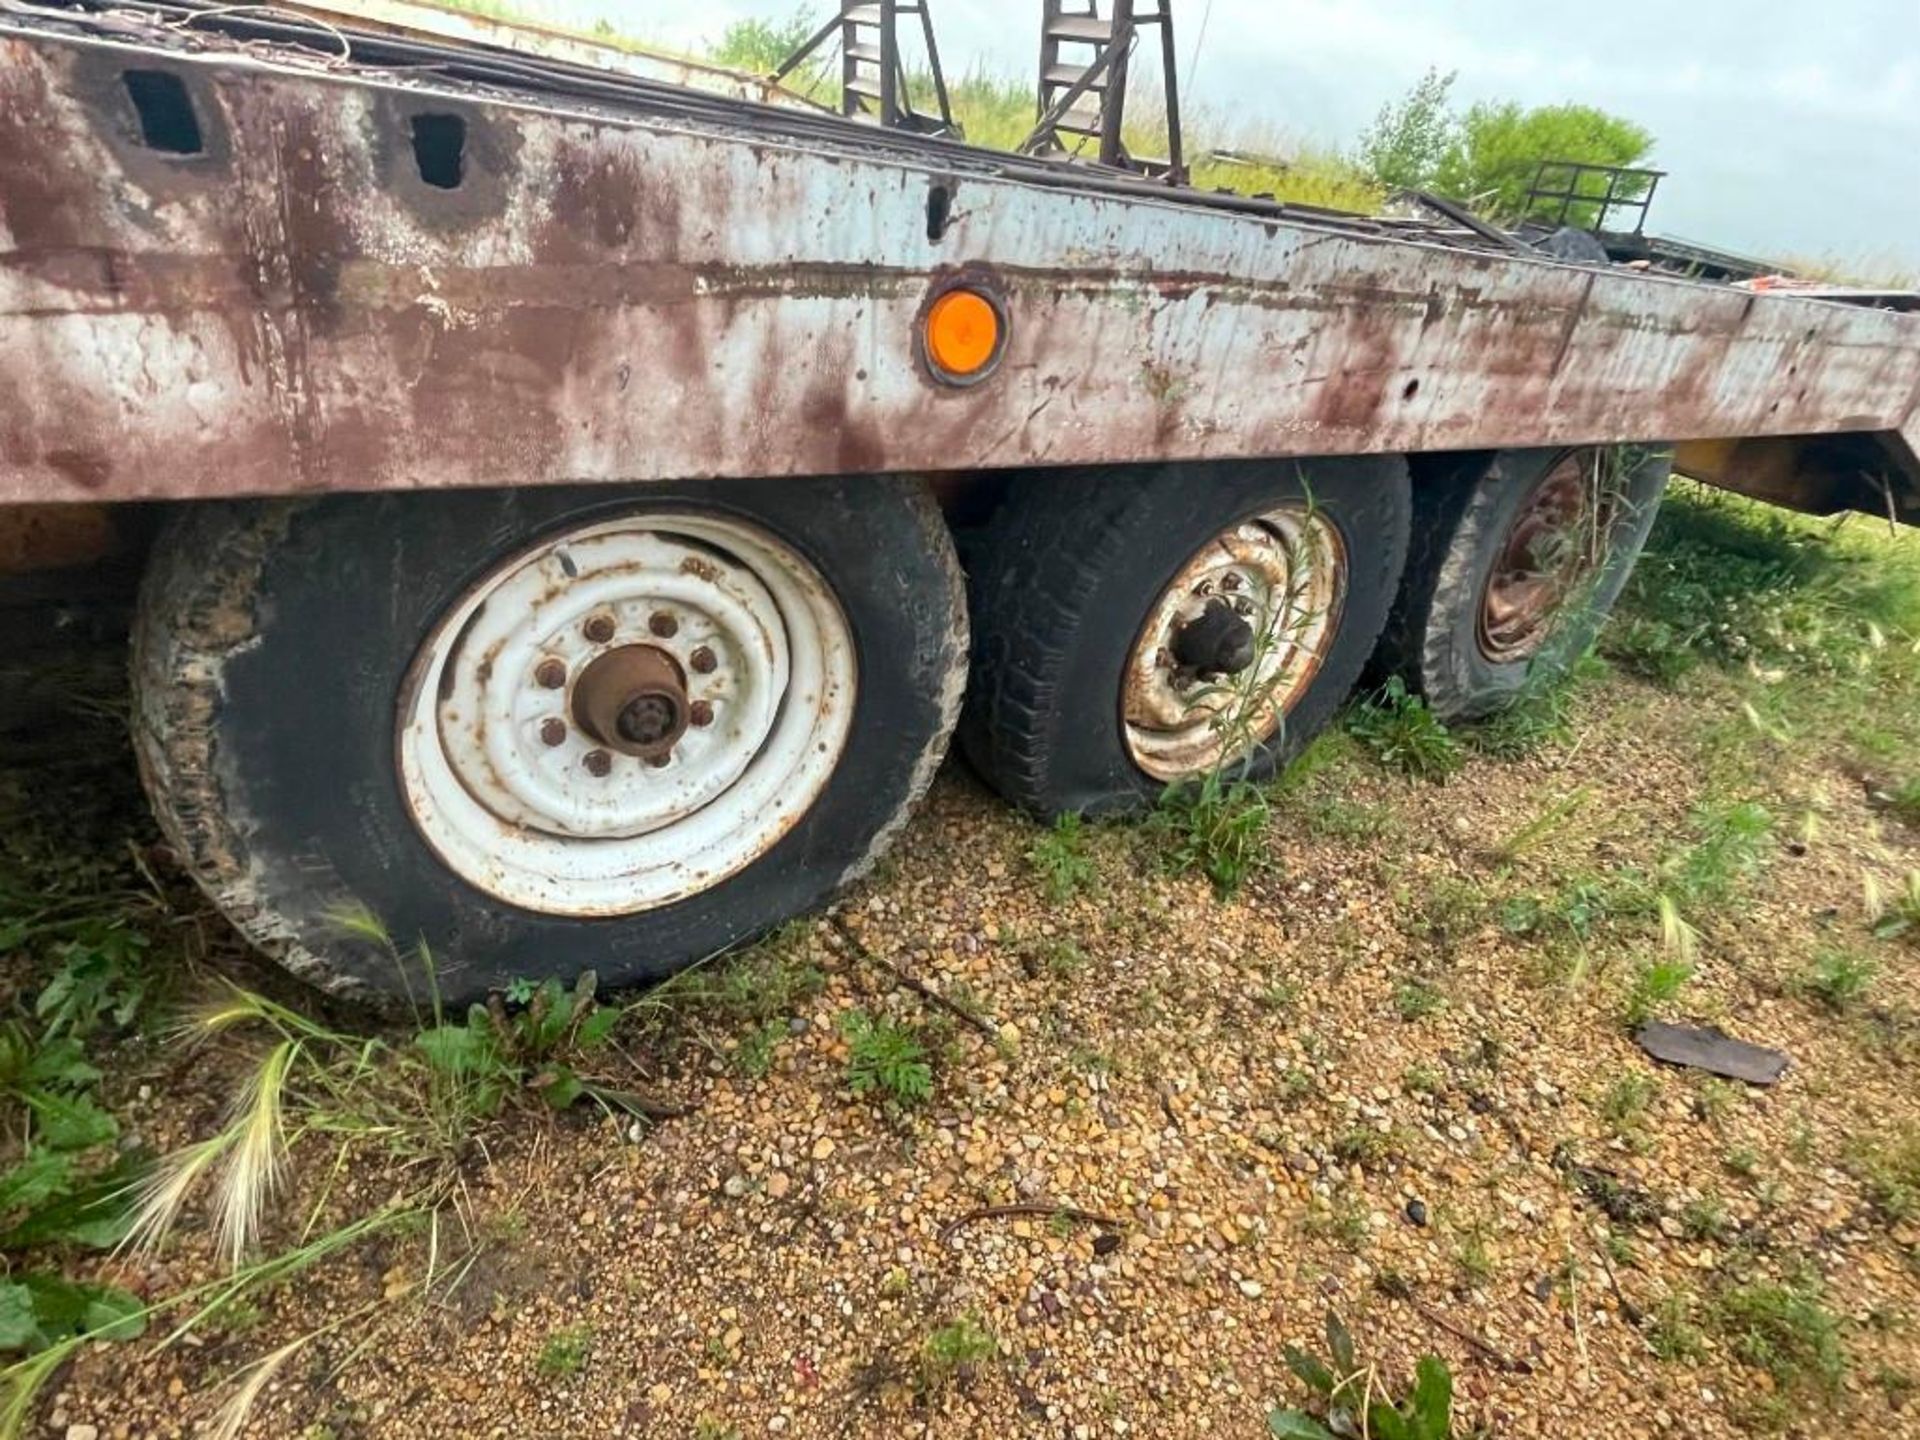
[1021,0,1187,182]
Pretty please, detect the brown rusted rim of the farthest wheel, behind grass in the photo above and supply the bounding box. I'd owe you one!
[1478,449,1605,664]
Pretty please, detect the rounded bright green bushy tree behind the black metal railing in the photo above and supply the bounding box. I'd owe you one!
[1432,100,1653,225]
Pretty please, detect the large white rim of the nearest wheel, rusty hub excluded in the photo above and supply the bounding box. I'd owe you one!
[397,513,856,916]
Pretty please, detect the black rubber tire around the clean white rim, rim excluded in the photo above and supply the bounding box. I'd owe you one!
[132,476,966,1000]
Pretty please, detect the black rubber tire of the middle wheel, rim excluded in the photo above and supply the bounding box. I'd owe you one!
[960,457,1409,816]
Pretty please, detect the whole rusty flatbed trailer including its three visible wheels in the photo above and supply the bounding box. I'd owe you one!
[0,0,1920,995]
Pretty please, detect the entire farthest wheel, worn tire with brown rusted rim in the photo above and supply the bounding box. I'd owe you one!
[1373,445,1672,720]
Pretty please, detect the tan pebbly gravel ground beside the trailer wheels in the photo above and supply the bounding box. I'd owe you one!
[33,680,1920,1440]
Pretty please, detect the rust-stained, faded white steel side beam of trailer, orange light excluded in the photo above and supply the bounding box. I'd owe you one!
[0,8,1920,503]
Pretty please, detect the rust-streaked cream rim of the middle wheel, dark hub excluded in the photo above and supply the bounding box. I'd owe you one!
[1121,501,1348,783]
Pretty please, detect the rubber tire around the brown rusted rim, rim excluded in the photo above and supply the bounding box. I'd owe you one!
[1375,447,1672,720]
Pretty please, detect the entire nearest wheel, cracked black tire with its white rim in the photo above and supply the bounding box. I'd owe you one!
[132,476,966,1000]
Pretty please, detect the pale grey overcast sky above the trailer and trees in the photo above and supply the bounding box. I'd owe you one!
[520,0,1920,273]
